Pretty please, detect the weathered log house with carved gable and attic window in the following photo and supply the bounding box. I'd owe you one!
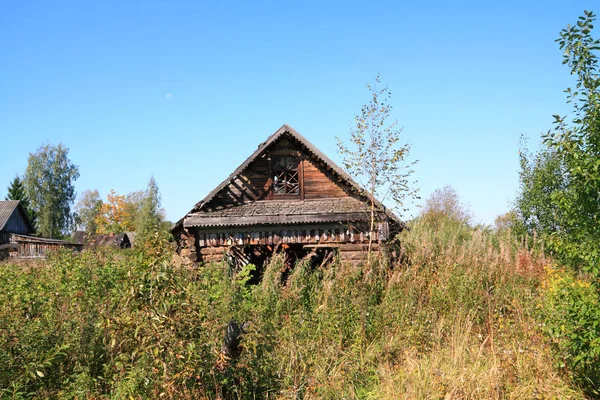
[172,125,406,264]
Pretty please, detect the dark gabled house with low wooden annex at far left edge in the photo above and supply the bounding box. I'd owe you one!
[0,200,81,259]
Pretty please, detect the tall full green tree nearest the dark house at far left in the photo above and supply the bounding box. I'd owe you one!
[24,144,79,238]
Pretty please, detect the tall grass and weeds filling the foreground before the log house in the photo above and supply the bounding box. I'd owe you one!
[0,219,582,399]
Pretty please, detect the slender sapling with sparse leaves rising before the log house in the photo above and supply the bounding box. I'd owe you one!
[336,74,416,263]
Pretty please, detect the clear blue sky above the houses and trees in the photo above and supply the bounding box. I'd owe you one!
[0,0,600,223]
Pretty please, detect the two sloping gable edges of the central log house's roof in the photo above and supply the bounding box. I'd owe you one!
[172,124,407,232]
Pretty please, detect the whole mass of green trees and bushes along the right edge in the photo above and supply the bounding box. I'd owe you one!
[516,11,600,396]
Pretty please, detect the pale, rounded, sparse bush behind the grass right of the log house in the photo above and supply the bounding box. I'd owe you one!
[421,185,471,224]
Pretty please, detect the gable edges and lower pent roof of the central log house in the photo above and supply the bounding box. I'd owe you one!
[172,124,406,232]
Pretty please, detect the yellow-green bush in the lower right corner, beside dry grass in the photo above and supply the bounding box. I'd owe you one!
[541,268,600,396]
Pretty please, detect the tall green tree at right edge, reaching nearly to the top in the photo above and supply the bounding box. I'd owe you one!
[544,11,600,277]
